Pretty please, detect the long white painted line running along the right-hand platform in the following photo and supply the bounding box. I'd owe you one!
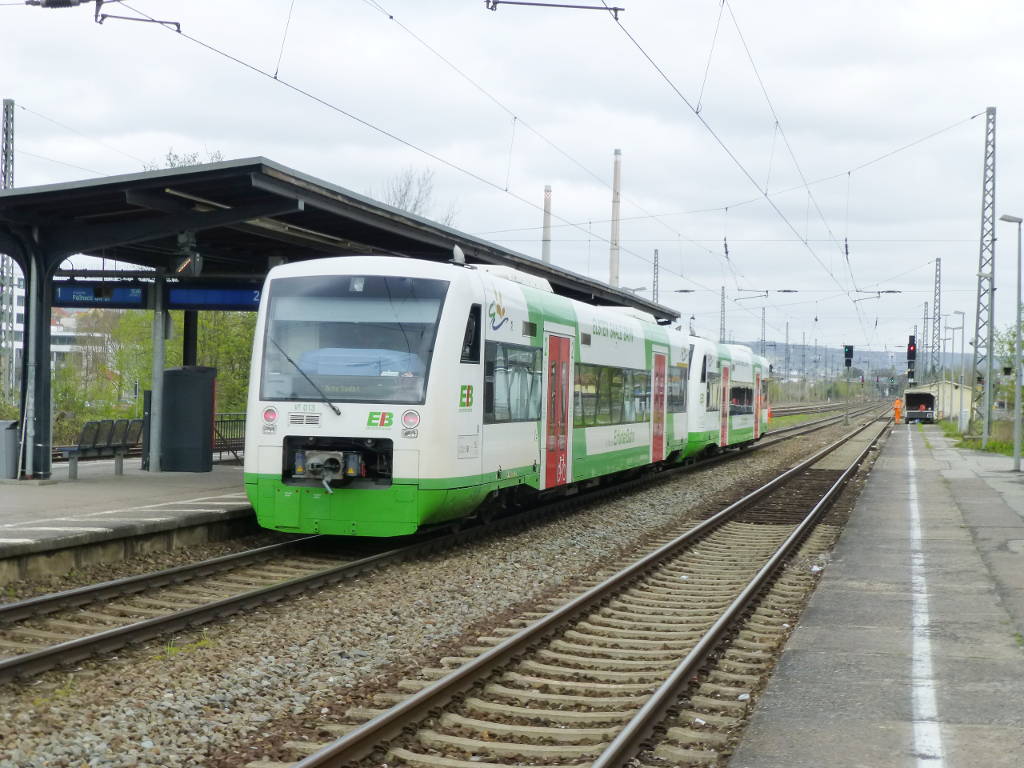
[906,429,944,768]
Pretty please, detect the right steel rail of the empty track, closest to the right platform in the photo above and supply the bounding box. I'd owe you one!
[591,421,885,768]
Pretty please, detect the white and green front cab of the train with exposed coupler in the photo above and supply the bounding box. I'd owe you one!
[239,257,495,537]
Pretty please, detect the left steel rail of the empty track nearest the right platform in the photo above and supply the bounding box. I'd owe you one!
[294,415,874,768]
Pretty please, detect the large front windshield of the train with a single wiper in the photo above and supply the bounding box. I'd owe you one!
[260,275,449,403]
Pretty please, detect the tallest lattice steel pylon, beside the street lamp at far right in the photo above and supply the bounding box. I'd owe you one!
[971,106,995,446]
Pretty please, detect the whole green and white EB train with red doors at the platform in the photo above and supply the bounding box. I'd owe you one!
[245,256,769,537]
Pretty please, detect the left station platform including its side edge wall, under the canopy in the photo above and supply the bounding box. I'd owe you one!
[0,459,255,585]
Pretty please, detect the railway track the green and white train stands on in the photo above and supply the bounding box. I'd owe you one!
[0,409,884,681]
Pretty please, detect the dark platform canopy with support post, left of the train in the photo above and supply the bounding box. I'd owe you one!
[0,158,679,478]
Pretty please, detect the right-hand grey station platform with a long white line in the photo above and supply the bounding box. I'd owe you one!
[729,425,1024,768]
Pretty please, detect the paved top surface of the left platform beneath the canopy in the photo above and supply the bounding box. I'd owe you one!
[0,459,252,560]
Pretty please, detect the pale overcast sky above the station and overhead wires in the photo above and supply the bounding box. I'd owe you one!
[0,0,1024,359]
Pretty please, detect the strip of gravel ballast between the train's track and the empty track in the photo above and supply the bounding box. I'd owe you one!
[0,427,856,768]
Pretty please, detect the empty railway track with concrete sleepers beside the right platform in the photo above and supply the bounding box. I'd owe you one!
[248,421,889,768]
